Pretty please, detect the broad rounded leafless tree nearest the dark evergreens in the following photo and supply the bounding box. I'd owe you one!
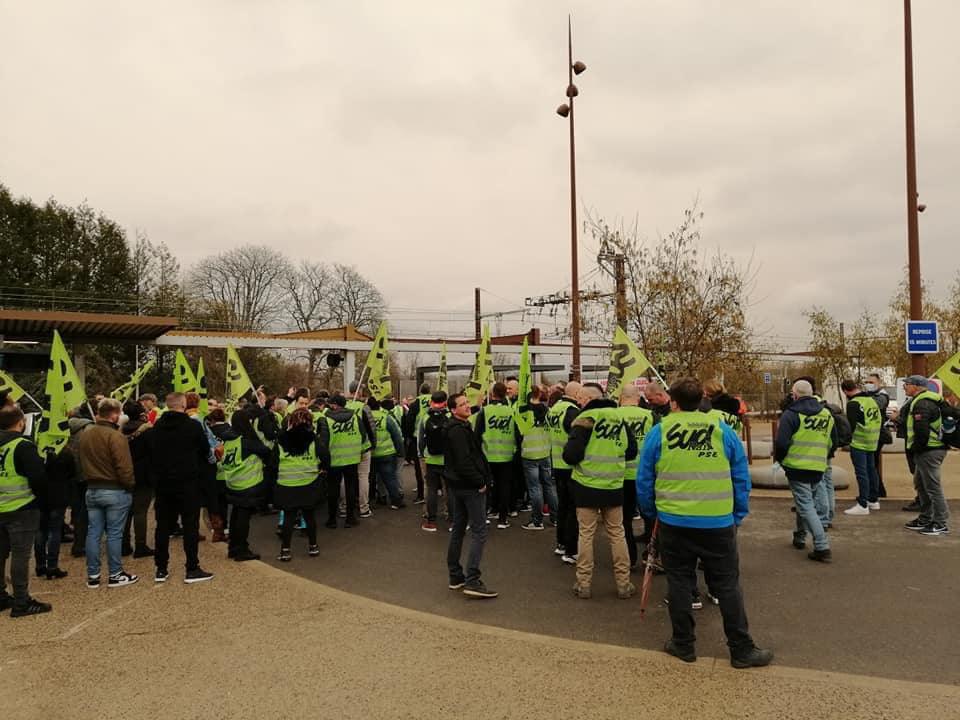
[190,245,294,332]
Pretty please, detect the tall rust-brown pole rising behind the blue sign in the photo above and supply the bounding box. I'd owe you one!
[903,0,927,375]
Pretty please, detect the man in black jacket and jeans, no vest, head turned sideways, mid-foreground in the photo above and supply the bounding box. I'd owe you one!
[443,393,497,598]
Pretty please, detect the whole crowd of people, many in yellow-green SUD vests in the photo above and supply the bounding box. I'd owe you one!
[0,368,948,667]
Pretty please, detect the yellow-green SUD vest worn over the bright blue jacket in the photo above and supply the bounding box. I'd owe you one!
[654,411,733,517]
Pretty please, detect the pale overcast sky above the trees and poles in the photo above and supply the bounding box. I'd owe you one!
[0,0,960,348]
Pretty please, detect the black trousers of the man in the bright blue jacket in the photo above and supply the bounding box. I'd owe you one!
[660,522,754,657]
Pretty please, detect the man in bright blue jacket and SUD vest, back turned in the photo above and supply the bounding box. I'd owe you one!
[637,378,773,668]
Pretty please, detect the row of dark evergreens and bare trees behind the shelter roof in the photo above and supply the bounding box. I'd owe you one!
[0,184,386,400]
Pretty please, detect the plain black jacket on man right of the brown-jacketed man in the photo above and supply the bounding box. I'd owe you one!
[143,410,210,495]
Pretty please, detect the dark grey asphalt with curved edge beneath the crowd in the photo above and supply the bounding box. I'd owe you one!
[251,467,960,685]
